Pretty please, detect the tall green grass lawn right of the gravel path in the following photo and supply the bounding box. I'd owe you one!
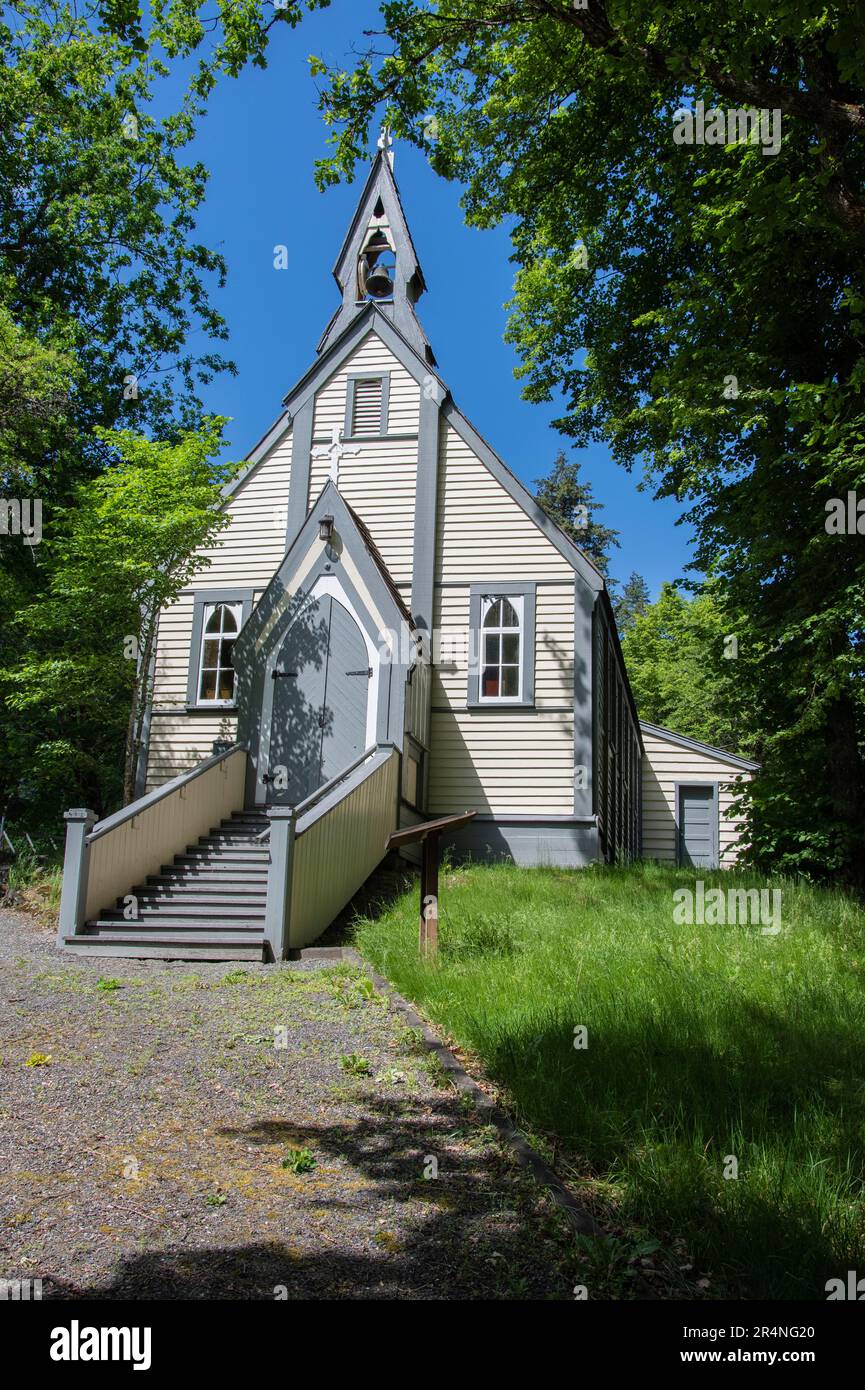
[356,865,865,1300]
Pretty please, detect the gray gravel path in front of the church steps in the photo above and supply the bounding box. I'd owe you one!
[0,912,570,1298]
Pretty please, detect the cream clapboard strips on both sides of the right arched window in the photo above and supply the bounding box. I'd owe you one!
[433,584,574,709]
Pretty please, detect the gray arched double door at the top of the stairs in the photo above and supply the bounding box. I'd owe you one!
[264,595,370,806]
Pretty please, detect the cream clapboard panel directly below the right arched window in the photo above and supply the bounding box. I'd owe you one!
[430,710,573,816]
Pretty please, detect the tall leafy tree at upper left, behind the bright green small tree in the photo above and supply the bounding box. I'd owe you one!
[0,0,327,816]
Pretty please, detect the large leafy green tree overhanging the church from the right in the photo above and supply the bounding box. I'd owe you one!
[318,0,865,883]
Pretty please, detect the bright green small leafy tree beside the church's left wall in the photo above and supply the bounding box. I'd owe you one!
[0,418,231,812]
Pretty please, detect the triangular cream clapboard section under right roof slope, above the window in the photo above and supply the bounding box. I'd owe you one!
[437,423,573,582]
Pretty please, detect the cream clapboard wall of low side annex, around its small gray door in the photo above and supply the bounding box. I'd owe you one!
[642,731,750,869]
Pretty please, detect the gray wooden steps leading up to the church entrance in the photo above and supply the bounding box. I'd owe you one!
[63,810,268,960]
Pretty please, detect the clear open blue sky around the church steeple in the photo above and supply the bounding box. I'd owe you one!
[169,0,690,598]
